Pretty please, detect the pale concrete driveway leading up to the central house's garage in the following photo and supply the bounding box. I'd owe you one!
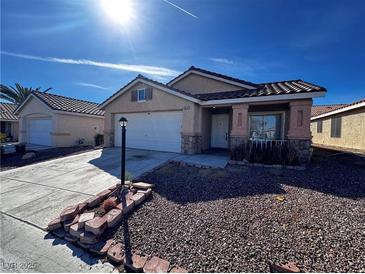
[0,148,179,228]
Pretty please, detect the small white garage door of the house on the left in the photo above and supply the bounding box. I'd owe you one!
[28,119,52,146]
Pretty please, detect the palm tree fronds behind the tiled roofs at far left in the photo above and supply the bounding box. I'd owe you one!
[0,83,52,105]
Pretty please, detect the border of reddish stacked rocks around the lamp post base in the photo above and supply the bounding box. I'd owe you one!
[47,181,188,273]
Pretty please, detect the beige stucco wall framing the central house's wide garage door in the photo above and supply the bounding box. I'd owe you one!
[104,83,201,146]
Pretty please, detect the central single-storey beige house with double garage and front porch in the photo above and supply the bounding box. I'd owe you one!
[100,67,326,162]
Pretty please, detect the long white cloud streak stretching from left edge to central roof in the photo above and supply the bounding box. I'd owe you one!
[1,51,180,77]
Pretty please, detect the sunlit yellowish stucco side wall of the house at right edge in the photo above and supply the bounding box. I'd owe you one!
[311,108,365,151]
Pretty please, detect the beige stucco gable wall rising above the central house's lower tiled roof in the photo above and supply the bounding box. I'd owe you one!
[172,74,242,94]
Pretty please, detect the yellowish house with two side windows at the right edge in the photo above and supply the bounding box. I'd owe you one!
[311,99,365,152]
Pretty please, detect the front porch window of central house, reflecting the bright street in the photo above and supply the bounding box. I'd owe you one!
[250,114,283,140]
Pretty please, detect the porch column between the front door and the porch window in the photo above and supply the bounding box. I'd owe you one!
[230,104,248,148]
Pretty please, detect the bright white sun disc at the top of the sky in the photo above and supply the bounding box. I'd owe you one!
[101,0,134,25]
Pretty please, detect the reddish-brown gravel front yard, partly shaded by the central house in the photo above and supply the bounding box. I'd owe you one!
[114,150,365,272]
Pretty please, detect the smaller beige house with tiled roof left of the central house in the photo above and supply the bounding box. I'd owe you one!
[15,91,104,147]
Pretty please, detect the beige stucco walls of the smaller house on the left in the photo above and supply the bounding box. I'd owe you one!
[19,98,104,147]
